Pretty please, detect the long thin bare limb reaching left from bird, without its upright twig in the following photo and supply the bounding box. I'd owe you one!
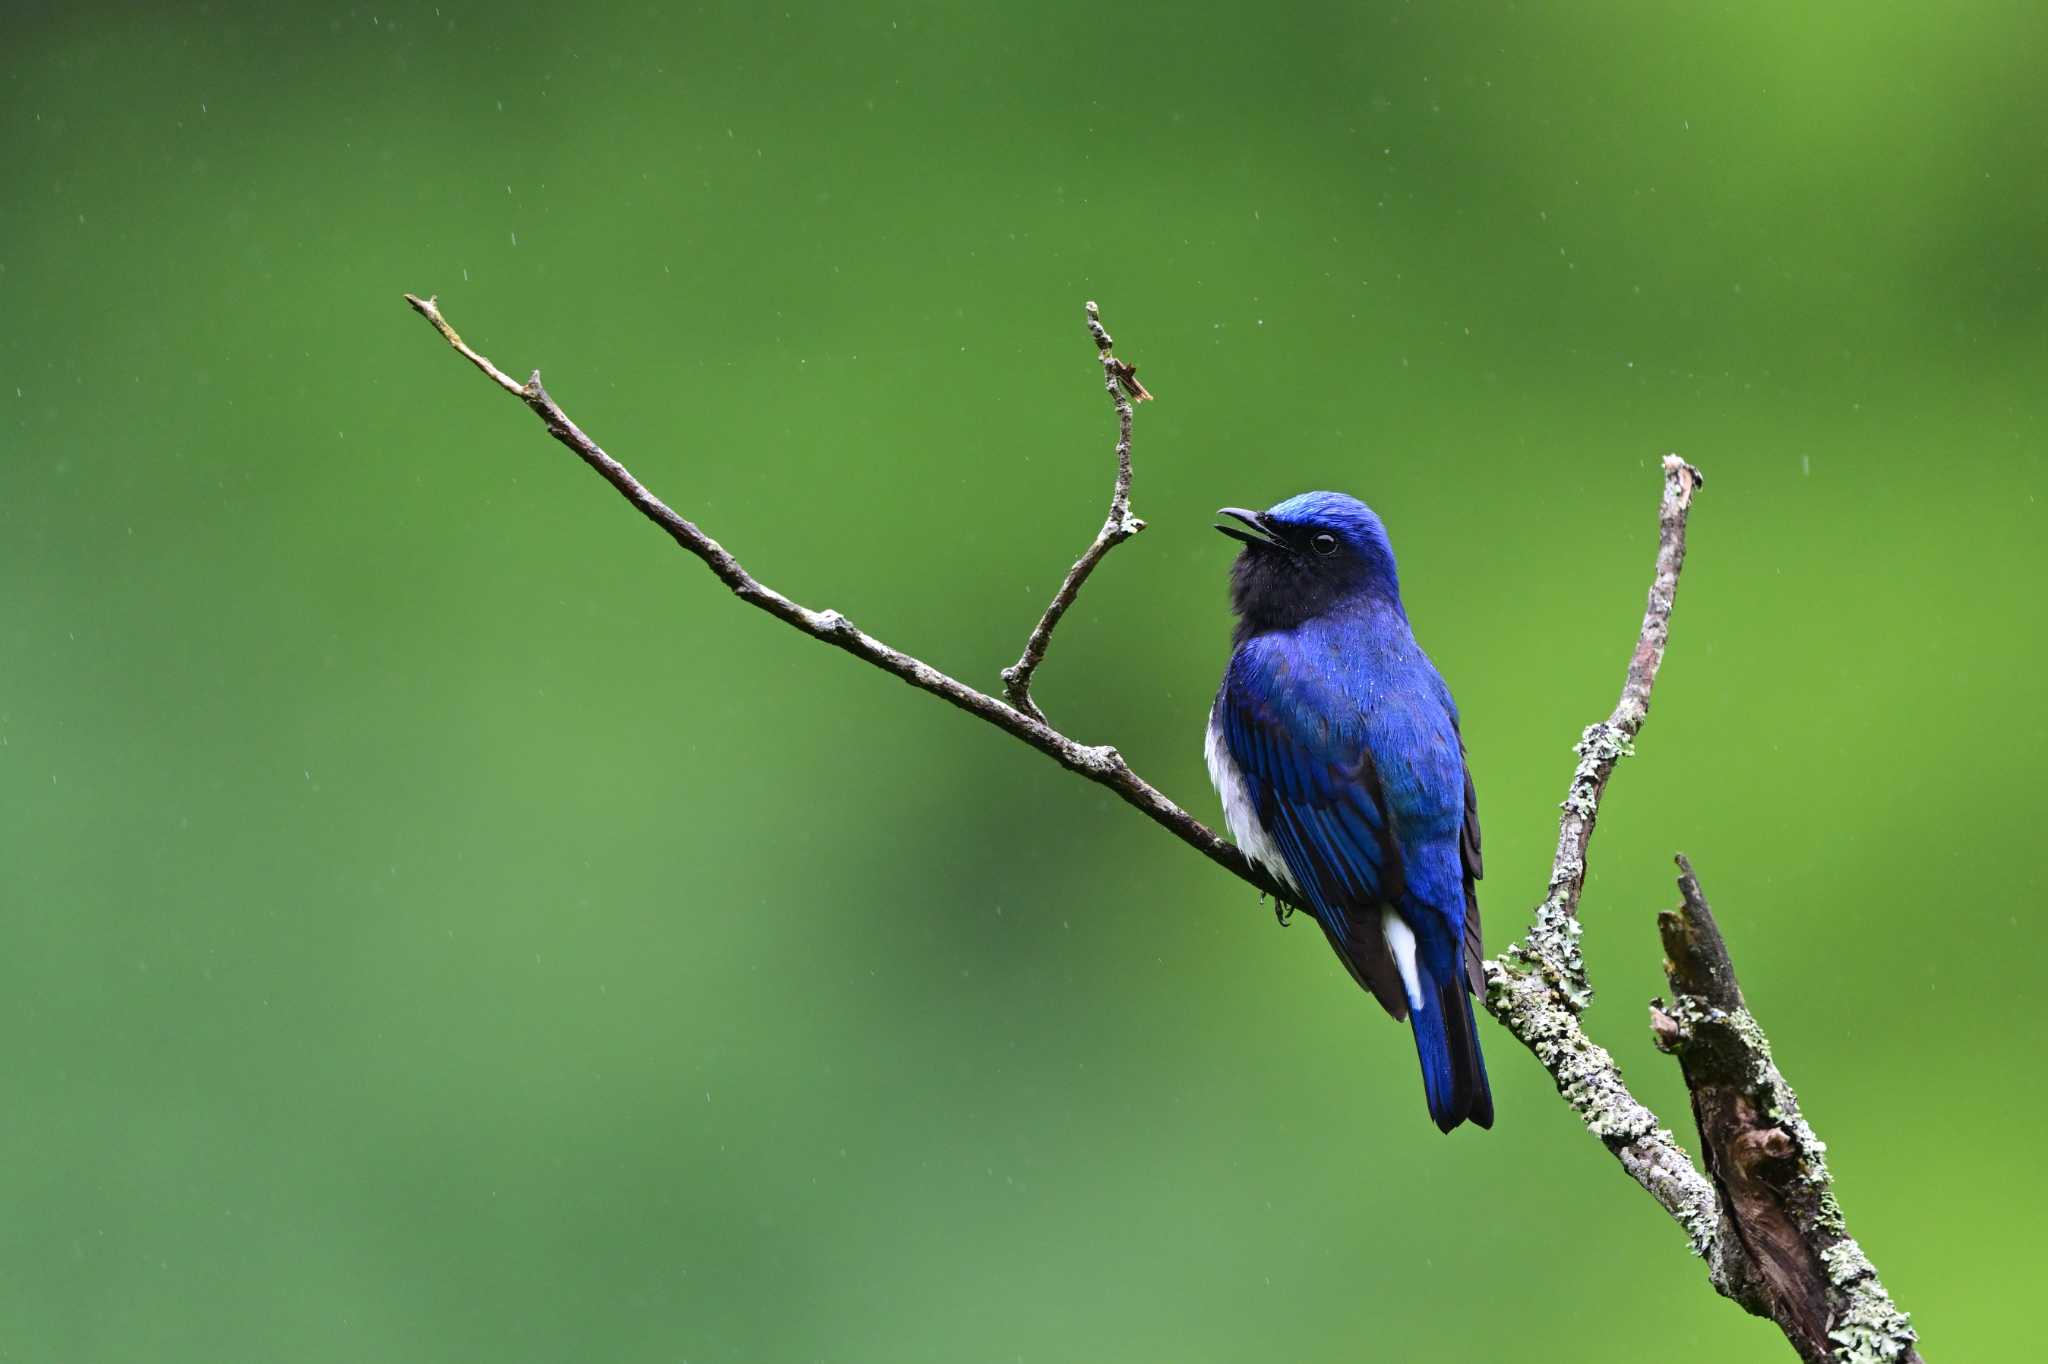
[406,293,1280,897]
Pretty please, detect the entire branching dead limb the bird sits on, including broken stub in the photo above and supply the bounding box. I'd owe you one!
[406,303,1921,1364]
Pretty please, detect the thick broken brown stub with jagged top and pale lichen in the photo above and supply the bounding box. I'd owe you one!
[1651,856,1919,1364]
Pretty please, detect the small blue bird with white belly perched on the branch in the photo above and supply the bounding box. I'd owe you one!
[1206,492,1493,1133]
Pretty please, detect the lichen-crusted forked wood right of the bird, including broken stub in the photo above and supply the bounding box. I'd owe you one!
[1485,455,1921,1364]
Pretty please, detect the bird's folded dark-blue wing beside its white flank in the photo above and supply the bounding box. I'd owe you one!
[1217,674,1407,1018]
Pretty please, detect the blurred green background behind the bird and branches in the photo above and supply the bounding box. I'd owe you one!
[0,0,2048,1362]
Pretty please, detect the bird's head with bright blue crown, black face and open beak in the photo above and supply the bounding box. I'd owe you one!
[1217,492,1401,637]
